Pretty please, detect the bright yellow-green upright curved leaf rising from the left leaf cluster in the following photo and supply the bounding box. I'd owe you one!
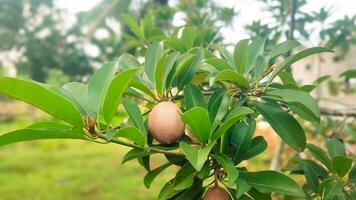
[103,68,139,124]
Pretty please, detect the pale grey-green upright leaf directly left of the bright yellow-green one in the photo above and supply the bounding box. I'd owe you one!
[88,62,117,116]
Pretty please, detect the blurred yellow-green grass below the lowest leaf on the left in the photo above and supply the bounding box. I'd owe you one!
[0,141,175,200]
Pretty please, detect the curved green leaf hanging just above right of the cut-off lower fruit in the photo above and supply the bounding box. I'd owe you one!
[213,154,239,186]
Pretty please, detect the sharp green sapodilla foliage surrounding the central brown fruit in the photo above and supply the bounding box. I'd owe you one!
[0,10,345,199]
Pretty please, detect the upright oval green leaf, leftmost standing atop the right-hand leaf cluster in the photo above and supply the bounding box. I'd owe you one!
[234,39,249,74]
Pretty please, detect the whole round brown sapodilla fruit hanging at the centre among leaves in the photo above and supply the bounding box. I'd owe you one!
[148,101,185,144]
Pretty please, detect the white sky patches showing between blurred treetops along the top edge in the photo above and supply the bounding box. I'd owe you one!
[55,0,356,43]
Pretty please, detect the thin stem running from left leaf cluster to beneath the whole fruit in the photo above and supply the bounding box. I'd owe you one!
[98,133,184,156]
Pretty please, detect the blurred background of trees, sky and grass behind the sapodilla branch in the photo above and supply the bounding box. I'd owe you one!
[0,0,356,200]
